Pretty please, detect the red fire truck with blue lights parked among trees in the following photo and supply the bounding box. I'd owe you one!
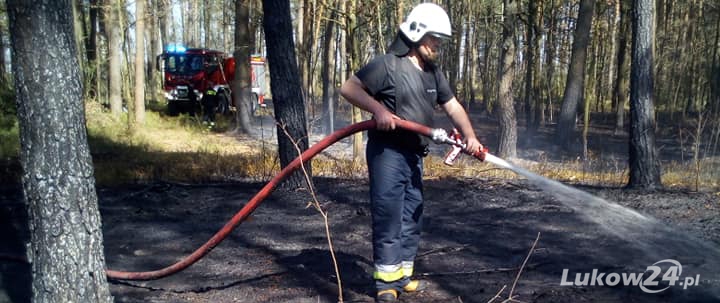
[157,44,265,115]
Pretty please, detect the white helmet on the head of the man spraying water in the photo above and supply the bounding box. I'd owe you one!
[400,3,452,43]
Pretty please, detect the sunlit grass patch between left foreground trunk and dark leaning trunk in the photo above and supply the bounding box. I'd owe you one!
[87,104,279,185]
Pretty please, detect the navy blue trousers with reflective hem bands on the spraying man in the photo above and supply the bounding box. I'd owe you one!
[366,138,423,290]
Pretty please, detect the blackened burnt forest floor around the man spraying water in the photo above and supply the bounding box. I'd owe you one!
[0,104,720,303]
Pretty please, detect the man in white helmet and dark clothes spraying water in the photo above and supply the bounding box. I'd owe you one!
[341,3,482,302]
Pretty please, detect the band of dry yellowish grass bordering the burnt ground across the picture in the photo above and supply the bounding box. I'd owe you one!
[0,102,720,191]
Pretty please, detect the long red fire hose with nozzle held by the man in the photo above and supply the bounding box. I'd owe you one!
[1,120,488,280]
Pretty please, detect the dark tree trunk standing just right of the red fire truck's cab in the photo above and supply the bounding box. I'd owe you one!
[232,0,257,134]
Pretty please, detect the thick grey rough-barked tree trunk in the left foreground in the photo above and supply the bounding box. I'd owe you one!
[7,0,113,302]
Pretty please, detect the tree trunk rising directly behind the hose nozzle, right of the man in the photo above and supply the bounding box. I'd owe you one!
[497,0,518,158]
